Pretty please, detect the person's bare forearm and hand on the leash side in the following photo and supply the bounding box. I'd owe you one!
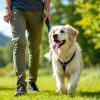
[44,0,50,20]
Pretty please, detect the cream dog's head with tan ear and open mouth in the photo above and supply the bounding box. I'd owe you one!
[49,25,78,49]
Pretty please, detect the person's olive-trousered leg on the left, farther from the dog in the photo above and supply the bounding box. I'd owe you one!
[11,9,26,86]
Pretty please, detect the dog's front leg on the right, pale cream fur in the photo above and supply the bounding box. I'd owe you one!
[67,71,80,95]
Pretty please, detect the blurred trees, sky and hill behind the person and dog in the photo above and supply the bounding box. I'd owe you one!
[0,0,100,75]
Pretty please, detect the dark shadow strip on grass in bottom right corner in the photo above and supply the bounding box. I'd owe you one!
[79,91,100,98]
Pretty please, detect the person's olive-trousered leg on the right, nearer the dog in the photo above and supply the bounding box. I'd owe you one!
[27,10,43,83]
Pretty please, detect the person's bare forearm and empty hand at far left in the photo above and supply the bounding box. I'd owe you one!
[4,0,11,23]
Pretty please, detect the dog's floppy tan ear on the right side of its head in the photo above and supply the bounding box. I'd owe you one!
[65,25,79,41]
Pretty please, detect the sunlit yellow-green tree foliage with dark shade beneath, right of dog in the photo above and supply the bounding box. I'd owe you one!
[74,0,100,63]
